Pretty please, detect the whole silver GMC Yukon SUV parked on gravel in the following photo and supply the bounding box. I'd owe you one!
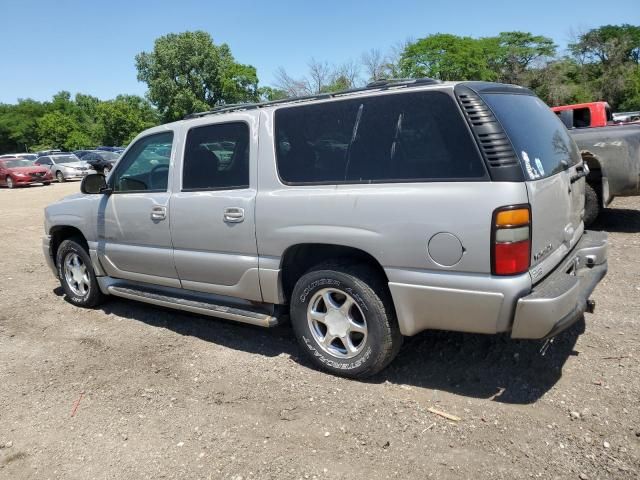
[43,79,607,377]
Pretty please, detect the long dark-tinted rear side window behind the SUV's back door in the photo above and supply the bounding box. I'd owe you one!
[275,92,485,184]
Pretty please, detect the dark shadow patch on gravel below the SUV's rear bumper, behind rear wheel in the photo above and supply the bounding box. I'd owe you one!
[371,318,585,404]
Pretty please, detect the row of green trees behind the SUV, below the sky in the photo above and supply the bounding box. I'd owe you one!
[0,24,640,152]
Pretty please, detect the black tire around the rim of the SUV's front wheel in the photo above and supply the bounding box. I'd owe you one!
[56,238,105,308]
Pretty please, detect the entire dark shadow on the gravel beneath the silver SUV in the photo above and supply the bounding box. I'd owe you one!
[55,288,584,404]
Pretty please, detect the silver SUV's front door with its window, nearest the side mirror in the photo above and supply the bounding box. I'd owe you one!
[97,131,180,287]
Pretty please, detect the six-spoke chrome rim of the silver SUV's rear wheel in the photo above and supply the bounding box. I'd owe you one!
[307,288,368,358]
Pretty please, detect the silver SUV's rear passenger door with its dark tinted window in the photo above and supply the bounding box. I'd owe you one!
[170,114,262,301]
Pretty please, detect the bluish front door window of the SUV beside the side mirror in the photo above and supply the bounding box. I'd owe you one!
[109,132,173,192]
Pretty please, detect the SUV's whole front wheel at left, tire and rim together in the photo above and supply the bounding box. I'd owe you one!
[56,238,104,308]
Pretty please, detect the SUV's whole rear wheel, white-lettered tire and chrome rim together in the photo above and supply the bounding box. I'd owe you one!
[290,264,402,378]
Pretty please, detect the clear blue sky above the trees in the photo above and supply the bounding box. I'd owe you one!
[0,0,640,103]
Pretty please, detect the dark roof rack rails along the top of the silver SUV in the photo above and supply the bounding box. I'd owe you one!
[184,77,442,120]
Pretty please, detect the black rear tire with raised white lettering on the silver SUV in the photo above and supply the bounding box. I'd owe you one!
[290,263,402,378]
